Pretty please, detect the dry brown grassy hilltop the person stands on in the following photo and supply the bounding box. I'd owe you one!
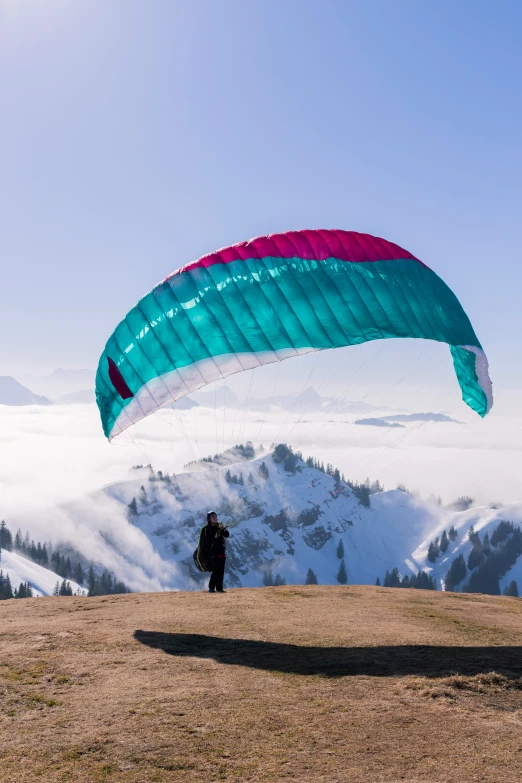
[0,586,522,783]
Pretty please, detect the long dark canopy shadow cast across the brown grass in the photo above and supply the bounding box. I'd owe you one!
[134,631,522,679]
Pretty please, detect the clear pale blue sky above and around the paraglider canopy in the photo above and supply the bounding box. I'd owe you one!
[0,0,522,410]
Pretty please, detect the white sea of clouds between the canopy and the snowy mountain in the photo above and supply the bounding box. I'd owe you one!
[0,398,522,517]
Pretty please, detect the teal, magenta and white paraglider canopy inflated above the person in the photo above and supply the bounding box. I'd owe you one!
[96,230,493,438]
